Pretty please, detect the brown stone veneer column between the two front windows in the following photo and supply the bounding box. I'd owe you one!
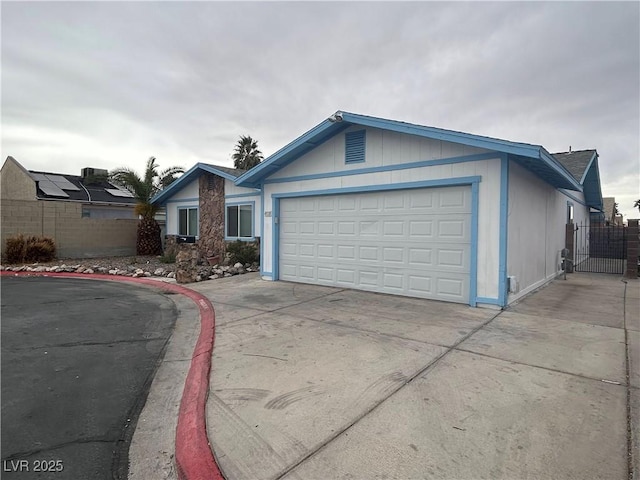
[198,173,226,259]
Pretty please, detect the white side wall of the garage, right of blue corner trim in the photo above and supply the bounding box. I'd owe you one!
[507,162,589,303]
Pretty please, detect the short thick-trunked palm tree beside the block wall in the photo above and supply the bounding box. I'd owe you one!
[109,157,184,255]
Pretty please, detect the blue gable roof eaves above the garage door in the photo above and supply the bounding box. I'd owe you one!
[236,111,581,190]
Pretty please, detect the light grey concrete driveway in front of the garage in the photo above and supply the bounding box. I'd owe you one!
[190,274,640,479]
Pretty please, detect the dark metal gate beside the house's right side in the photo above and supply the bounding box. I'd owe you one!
[573,223,627,274]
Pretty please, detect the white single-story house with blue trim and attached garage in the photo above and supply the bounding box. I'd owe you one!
[154,111,603,307]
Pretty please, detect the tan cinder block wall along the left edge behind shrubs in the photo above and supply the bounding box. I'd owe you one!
[0,200,138,258]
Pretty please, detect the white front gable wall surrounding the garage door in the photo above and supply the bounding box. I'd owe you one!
[261,128,501,299]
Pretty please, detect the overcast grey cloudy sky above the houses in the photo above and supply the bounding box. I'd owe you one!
[0,2,640,218]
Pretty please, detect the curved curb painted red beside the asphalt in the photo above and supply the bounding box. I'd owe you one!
[0,271,224,480]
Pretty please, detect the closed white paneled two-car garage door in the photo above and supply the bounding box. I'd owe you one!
[278,187,471,303]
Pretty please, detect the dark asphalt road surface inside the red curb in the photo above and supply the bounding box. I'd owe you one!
[0,277,177,480]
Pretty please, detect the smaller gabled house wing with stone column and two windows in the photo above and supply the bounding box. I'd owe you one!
[152,163,262,257]
